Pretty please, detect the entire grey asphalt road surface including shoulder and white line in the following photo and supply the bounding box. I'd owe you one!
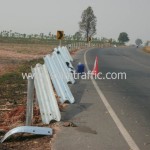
[54,47,150,150]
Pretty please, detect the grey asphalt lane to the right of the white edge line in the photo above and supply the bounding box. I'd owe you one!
[86,47,150,150]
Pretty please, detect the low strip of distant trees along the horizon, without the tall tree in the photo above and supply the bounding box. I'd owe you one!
[0,30,118,44]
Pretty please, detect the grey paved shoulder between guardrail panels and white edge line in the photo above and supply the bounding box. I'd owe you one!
[53,50,129,150]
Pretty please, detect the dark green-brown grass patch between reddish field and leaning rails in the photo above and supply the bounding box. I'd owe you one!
[0,58,43,105]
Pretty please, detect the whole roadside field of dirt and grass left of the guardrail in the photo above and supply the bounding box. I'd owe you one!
[0,43,54,150]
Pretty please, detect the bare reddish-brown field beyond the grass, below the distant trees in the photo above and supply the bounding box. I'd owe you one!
[0,43,54,75]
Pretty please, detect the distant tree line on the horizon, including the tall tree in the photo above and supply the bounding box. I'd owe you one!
[0,6,142,45]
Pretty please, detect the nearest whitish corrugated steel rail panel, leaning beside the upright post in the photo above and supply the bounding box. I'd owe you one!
[32,64,61,124]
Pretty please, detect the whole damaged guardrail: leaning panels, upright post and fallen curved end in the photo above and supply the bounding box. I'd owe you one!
[0,47,75,143]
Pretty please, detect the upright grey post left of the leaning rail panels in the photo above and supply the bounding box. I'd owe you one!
[26,77,34,126]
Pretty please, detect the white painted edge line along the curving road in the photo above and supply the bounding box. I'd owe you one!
[84,50,140,150]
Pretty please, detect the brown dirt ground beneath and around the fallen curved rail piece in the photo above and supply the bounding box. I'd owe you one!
[0,120,60,150]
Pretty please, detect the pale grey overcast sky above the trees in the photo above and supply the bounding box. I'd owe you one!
[0,0,150,43]
